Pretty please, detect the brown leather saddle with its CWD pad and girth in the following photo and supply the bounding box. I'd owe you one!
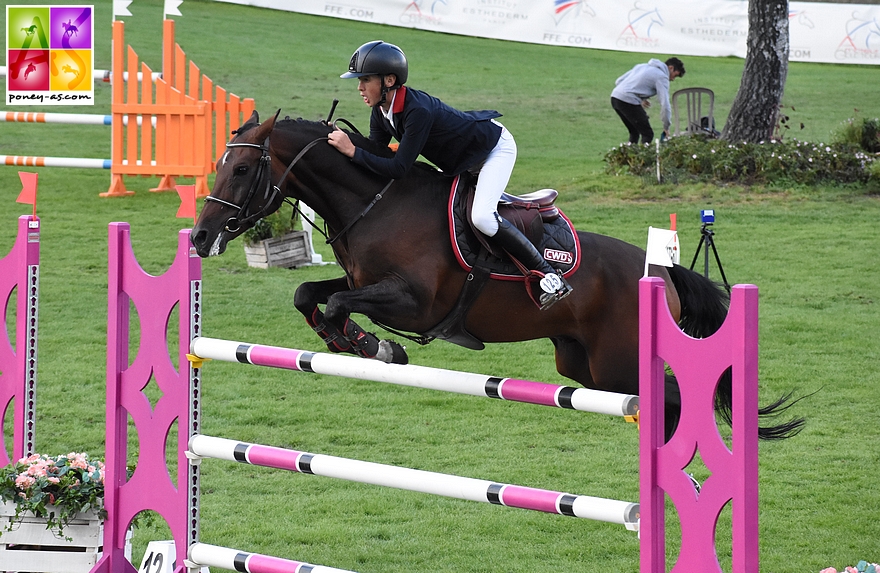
[422,173,580,350]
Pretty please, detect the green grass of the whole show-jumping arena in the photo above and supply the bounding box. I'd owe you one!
[0,0,880,573]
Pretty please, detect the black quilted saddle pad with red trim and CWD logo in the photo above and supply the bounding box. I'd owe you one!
[448,176,580,281]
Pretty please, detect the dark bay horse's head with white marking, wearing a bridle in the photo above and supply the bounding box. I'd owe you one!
[192,111,284,257]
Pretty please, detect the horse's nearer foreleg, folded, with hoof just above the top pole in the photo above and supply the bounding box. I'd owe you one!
[324,279,418,364]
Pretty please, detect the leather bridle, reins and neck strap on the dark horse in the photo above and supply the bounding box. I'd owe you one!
[205,122,394,245]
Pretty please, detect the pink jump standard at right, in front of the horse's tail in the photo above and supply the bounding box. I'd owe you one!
[639,278,758,573]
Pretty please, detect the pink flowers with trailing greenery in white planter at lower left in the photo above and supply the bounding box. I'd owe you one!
[0,452,134,572]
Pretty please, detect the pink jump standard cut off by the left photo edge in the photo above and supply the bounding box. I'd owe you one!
[0,215,40,466]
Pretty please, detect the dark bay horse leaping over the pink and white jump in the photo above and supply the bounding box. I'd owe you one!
[192,113,803,439]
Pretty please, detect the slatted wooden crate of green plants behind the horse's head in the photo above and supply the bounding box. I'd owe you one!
[242,204,312,269]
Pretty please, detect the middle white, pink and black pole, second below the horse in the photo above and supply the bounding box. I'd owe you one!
[189,435,639,531]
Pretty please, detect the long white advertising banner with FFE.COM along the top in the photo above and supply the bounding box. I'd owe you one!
[213,0,880,64]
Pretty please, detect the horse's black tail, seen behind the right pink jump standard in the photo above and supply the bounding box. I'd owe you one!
[667,265,805,440]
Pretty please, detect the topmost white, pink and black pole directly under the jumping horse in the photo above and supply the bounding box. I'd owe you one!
[190,336,639,421]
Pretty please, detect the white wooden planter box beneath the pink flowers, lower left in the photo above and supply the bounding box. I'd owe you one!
[0,502,131,573]
